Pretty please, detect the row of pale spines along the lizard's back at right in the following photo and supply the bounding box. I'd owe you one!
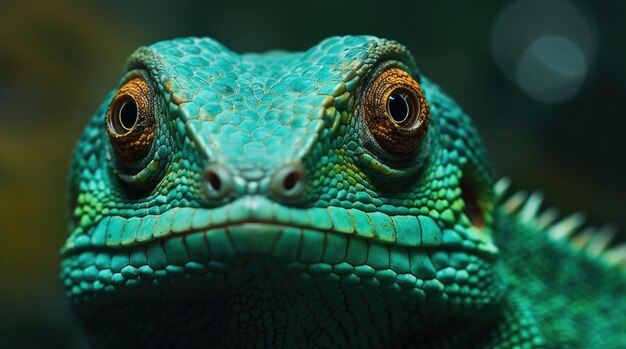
[494,177,626,272]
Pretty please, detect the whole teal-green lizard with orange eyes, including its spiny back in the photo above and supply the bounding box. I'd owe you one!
[60,36,626,349]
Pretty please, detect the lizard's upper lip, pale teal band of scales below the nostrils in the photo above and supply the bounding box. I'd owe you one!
[62,196,497,259]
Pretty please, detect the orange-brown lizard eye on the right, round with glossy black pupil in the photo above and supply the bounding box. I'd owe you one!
[362,68,430,155]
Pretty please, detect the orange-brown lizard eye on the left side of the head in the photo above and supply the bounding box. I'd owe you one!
[106,78,155,161]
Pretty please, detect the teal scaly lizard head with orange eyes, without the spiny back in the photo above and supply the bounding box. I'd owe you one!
[61,36,502,346]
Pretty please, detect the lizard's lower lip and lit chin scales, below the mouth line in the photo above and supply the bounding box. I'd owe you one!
[61,218,497,304]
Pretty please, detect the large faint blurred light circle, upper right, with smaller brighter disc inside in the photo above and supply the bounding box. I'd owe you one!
[491,0,598,103]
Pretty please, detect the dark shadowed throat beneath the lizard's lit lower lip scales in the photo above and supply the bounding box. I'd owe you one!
[74,258,487,348]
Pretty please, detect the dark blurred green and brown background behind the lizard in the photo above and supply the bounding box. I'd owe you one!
[0,0,626,348]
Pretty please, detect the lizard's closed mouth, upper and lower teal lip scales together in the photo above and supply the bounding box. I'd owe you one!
[61,196,498,300]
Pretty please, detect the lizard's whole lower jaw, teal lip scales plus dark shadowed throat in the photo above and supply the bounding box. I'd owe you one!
[63,222,498,347]
